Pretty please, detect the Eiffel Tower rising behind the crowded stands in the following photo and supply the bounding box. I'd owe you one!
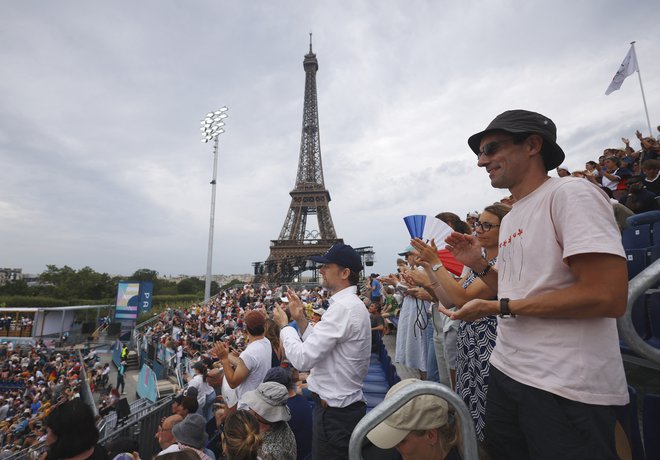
[252,34,343,283]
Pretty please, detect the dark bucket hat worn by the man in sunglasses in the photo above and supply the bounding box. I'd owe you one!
[468,109,566,171]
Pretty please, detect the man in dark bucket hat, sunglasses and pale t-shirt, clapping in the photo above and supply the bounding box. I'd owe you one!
[447,110,628,460]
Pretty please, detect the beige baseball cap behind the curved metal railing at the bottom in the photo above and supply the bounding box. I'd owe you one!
[367,379,449,449]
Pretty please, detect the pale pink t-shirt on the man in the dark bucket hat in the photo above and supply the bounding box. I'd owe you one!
[491,177,628,405]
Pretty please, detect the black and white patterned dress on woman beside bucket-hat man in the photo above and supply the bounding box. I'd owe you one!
[456,258,497,441]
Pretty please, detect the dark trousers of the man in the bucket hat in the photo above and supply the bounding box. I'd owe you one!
[485,366,619,460]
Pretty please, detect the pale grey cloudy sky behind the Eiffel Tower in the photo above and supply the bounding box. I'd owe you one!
[0,0,660,275]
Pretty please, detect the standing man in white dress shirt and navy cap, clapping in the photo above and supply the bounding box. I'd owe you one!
[273,243,371,460]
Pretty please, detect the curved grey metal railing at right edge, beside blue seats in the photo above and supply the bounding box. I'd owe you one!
[617,259,660,365]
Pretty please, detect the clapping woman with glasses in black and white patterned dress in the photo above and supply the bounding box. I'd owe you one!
[412,203,511,440]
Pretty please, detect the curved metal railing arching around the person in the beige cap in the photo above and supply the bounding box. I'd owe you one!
[348,382,479,460]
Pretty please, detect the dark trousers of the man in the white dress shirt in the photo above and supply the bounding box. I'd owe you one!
[312,398,367,460]
